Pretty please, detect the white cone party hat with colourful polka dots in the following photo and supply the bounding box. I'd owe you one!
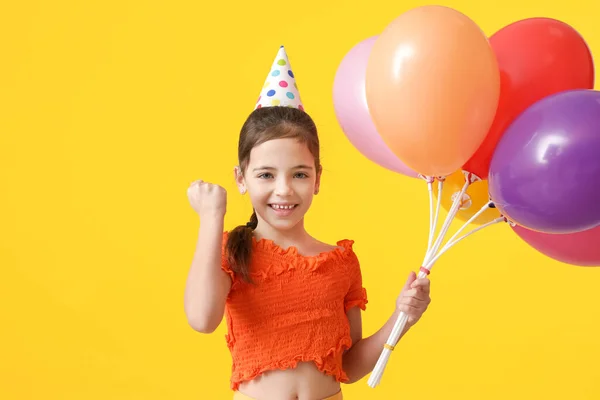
[254,46,304,111]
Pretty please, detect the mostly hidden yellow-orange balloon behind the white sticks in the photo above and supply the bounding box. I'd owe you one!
[433,170,500,225]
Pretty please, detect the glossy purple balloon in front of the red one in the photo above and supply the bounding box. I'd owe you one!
[488,89,600,233]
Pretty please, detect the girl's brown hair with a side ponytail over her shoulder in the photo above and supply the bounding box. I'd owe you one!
[226,106,321,282]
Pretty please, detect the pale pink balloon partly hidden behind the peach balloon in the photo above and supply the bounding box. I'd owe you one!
[333,36,418,178]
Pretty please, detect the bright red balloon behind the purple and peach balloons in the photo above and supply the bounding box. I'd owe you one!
[463,18,594,179]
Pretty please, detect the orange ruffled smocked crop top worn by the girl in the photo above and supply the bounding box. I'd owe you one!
[221,232,367,390]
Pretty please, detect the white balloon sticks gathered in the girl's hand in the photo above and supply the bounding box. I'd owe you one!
[368,172,510,388]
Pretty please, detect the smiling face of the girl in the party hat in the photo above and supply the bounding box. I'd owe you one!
[236,138,321,230]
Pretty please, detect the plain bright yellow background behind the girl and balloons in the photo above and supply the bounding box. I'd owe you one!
[0,0,600,400]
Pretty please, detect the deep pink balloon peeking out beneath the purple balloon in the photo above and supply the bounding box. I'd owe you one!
[513,225,600,267]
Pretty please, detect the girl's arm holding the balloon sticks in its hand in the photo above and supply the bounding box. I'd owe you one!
[343,272,431,383]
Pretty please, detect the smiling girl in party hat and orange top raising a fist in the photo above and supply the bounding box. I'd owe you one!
[185,47,430,400]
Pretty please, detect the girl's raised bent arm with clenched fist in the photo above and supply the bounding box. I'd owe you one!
[184,183,231,333]
